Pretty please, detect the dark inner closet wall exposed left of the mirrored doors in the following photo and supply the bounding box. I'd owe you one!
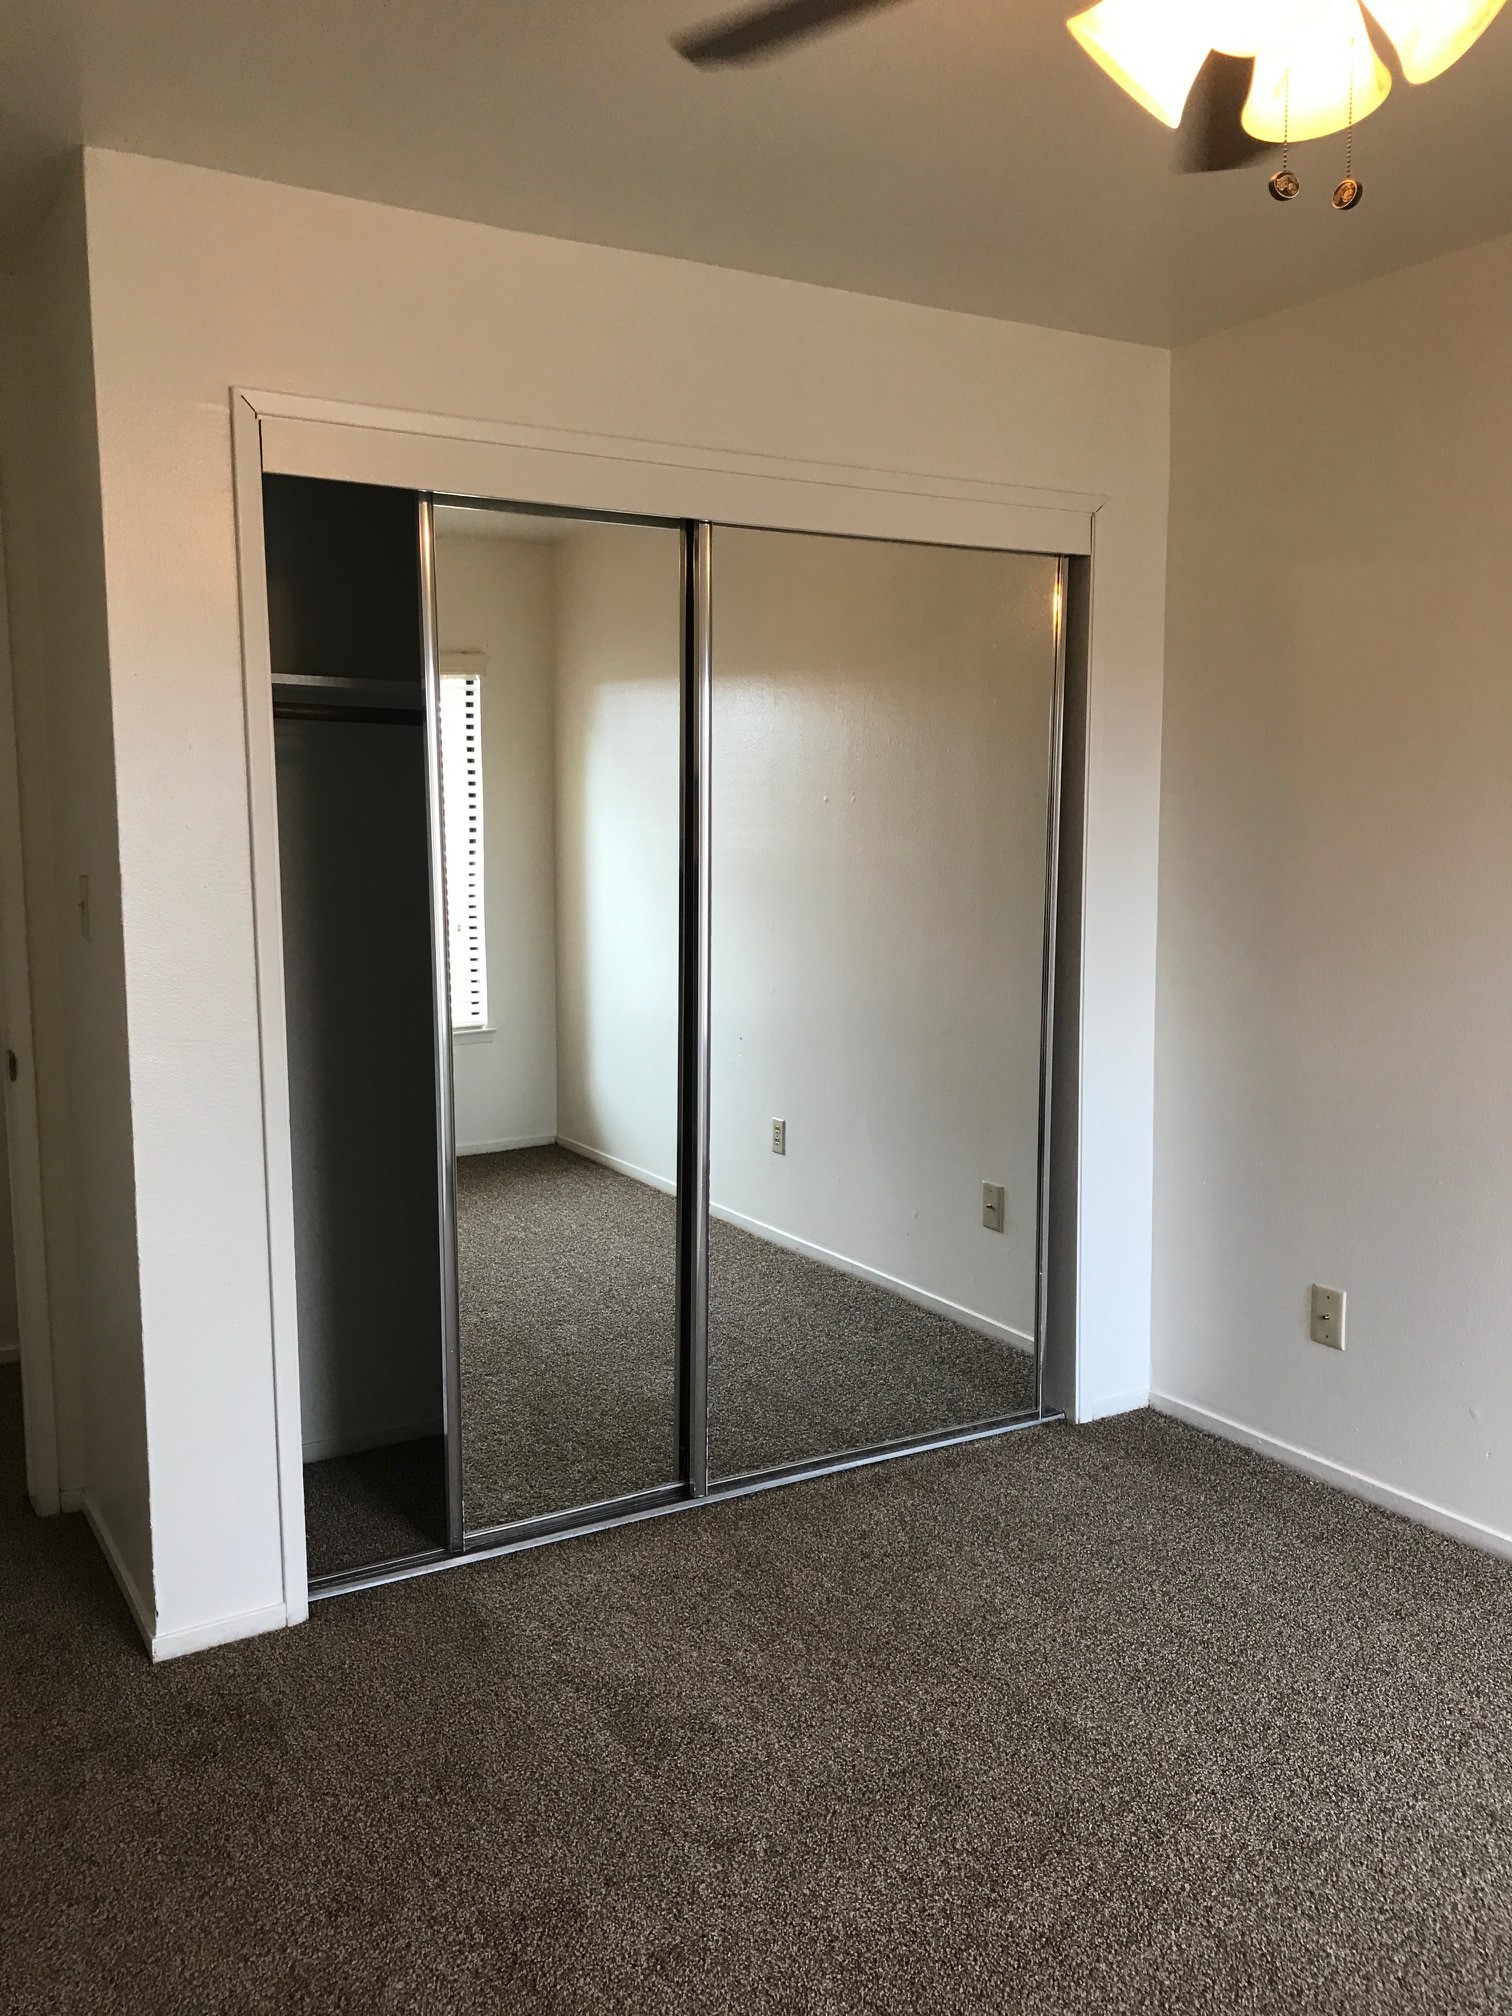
[264,476,442,1462]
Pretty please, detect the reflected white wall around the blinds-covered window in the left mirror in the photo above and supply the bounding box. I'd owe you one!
[435,528,556,1155]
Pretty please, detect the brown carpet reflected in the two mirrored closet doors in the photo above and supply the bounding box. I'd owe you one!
[458,1147,1034,1530]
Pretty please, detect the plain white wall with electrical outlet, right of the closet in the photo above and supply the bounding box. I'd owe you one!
[1153,240,1512,1544]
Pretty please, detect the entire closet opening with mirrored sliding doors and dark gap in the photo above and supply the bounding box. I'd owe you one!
[264,476,1070,1595]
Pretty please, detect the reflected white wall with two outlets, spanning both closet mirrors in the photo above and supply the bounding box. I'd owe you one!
[558,528,1054,1345]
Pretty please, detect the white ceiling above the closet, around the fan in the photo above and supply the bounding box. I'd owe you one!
[0,0,1512,344]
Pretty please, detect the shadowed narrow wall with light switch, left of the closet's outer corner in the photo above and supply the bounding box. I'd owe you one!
[0,167,151,1631]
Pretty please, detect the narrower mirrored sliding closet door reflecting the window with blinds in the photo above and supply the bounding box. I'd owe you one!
[435,500,681,1542]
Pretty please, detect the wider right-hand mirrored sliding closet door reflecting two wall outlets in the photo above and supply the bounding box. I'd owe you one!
[708,526,1058,1480]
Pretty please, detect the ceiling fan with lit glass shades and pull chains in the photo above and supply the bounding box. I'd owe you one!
[673,0,1504,188]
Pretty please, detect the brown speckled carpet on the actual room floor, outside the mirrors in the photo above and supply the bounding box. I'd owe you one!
[0,1367,1512,2016]
